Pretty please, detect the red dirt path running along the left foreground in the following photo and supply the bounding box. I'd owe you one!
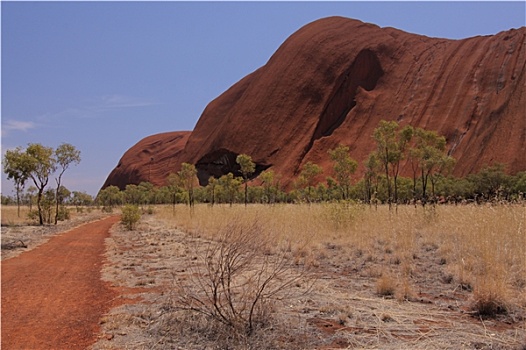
[1,216,119,350]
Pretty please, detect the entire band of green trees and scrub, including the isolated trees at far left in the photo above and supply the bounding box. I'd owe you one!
[2,121,526,217]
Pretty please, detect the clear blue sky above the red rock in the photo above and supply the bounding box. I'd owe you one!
[1,1,526,195]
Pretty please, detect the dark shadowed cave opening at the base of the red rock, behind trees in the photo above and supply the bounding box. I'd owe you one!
[195,148,270,186]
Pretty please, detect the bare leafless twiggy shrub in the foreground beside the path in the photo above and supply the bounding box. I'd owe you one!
[174,221,312,339]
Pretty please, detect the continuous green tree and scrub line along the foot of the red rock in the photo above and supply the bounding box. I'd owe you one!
[93,121,526,207]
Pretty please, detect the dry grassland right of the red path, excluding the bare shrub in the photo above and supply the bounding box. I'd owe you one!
[93,203,526,349]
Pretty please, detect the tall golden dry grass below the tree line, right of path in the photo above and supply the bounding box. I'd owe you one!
[157,203,526,310]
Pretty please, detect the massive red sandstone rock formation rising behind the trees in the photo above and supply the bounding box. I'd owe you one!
[104,17,526,188]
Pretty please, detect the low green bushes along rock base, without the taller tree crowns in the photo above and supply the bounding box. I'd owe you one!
[96,161,526,210]
